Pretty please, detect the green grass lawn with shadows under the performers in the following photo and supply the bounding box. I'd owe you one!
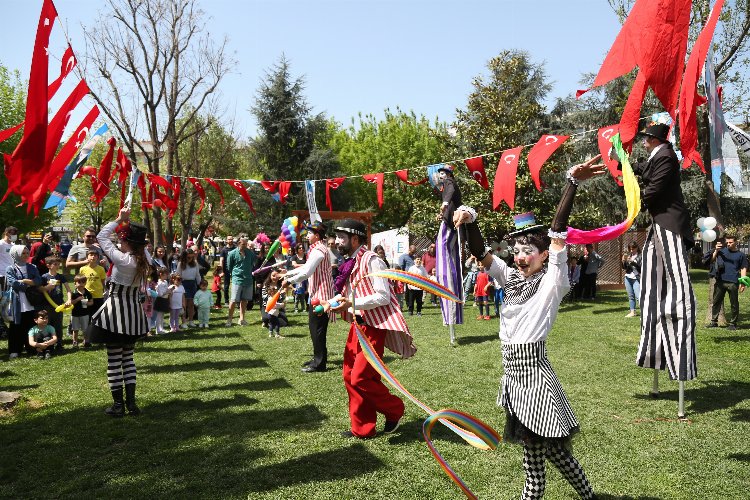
[0,271,750,499]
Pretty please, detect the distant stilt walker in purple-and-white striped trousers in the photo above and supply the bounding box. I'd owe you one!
[435,164,464,345]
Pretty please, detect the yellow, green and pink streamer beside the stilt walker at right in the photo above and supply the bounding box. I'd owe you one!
[567,134,641,245]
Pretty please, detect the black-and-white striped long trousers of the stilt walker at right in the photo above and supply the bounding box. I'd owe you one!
[636,223,698,381]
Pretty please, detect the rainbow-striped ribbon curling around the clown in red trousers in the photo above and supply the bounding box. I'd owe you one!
[350,269,501,499]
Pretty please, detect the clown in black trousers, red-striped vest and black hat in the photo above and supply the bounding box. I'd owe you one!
[281,221,336,373]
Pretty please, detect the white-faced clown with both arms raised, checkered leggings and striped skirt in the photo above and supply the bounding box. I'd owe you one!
[454,156,605,499]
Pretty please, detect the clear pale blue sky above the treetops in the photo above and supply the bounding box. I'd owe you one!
[0,0,620,139]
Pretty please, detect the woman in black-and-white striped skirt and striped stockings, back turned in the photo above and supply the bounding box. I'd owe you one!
[88,206,151,417]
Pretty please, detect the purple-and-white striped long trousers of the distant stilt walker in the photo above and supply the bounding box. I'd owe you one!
[435,222,464,325]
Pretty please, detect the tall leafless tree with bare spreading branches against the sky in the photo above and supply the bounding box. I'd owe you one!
[82,0,232,246]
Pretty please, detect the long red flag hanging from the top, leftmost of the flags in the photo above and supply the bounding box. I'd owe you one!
[0,0,57,203]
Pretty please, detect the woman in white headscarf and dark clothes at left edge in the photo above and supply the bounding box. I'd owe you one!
[5,245,43,359]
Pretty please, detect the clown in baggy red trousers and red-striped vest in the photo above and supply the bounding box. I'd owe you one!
[332,219,417,439]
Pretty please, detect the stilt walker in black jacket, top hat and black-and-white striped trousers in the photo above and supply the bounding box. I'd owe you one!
[633,124,698,418]
